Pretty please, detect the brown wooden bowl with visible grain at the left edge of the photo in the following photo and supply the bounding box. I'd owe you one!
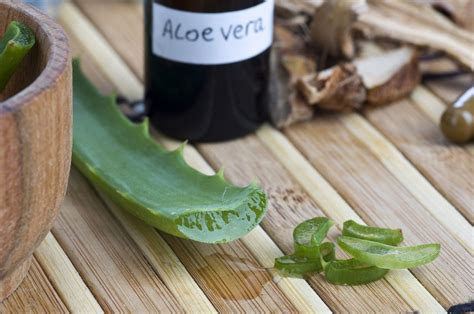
[0,0,72,301]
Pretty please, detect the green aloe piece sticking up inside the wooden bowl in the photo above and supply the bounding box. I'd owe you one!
[0,21,35,92]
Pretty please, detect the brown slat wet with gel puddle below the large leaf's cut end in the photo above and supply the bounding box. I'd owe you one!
[163,234,297,313]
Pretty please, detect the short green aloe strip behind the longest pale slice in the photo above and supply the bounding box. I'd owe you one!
[342,220,403,245]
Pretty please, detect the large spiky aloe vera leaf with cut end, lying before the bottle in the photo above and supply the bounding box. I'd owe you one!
[73,61,267,243]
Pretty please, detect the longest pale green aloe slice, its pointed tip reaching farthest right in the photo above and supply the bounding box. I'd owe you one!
[337,236,440,269]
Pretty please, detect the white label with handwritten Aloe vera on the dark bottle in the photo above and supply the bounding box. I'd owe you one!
[153,0,274,65]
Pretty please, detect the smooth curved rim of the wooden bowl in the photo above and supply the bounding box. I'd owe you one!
[0,0,70,116]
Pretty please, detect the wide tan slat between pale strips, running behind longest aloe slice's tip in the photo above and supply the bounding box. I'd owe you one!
[285,116,473,307]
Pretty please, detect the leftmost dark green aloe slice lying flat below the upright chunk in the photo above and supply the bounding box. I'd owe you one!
[274,242,335,278]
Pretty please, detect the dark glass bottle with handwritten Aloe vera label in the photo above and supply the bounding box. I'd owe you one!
[145,0,273,141]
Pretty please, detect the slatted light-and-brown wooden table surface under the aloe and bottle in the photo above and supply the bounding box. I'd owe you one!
[0,0,474,313]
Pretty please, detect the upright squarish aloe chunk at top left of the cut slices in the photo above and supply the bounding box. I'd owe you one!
[293,217,334,258]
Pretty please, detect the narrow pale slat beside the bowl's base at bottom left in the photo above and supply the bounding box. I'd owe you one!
[35,233,103,313]
